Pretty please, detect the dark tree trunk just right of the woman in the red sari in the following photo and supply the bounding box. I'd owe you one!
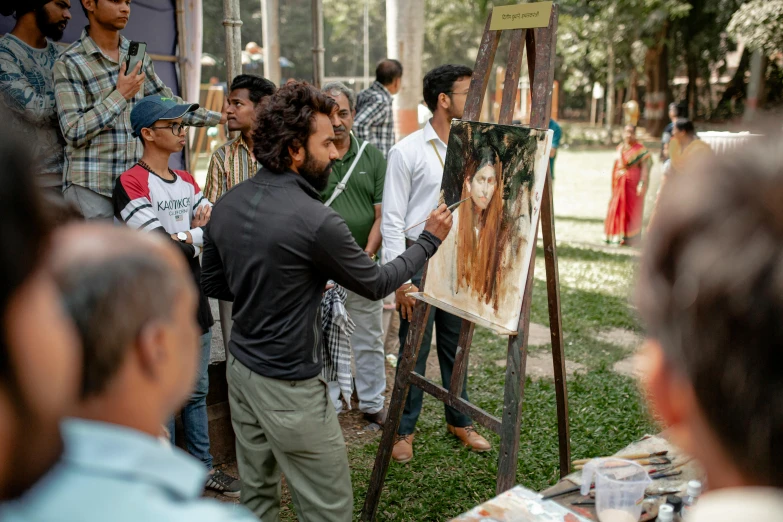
[644,27,671,136]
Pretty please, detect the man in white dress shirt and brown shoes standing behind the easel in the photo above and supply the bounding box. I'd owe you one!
[381,65,491,463]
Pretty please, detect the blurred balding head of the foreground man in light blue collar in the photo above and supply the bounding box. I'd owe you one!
[52,224,200,435]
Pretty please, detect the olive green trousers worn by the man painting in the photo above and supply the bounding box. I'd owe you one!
[226,354,353,522]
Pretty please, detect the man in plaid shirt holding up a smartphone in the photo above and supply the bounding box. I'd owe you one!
[54,0,225,219]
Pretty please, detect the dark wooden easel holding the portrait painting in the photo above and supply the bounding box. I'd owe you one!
[361,5,571,521]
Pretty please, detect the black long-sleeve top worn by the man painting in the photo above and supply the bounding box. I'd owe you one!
[201,168,440,380]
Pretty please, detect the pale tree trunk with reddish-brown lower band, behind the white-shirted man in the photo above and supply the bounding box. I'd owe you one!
[386,0,426,139]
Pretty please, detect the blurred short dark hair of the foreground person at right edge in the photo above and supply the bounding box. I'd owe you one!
[636,132,783,488]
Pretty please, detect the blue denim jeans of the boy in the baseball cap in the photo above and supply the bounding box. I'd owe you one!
[169,330,212,470]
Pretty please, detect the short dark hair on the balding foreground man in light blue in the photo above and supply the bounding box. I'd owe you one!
[56,252,182,399]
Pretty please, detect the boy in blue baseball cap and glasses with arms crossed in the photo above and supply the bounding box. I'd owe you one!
[113,96,239,497]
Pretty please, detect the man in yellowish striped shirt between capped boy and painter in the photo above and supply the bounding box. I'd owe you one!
[204,74,275,203]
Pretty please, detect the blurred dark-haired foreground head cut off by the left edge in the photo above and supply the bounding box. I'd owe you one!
[0,129,79,500]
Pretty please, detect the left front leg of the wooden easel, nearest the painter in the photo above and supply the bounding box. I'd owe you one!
[361,296,430,521]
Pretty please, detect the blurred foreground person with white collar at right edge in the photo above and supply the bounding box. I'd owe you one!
[636,131,783,522]
